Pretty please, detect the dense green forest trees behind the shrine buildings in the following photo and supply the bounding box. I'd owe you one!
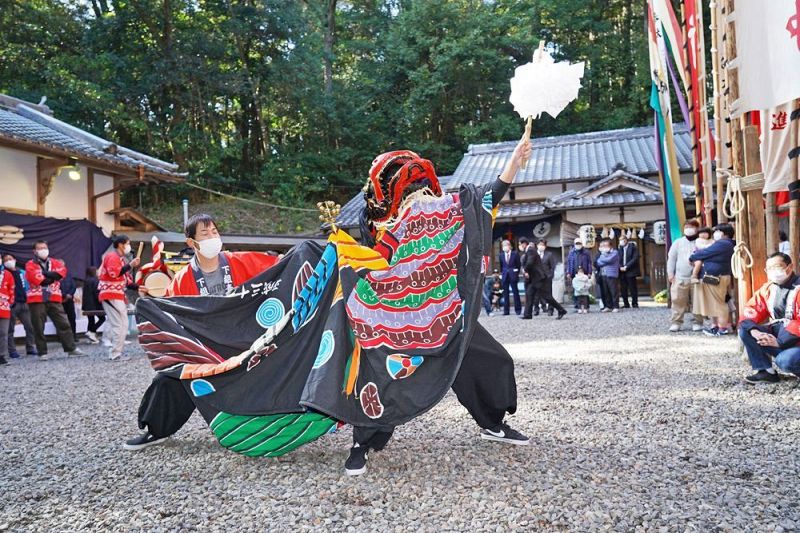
[0,0,650,212]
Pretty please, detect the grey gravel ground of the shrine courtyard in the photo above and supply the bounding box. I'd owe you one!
[0,306,800,531]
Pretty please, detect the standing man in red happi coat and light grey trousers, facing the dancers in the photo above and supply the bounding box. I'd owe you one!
[97,234,139,361]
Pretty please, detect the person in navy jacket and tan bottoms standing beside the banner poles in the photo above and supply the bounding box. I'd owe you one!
[689,224,734,337]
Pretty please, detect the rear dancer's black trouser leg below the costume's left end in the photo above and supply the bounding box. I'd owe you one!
[139,374,194,439]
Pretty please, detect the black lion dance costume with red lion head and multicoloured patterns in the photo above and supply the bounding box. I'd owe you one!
[137,151,527,462]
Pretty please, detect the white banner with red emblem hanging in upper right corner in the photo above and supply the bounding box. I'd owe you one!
[728,0,800,116]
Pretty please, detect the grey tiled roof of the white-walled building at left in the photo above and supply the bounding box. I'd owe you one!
[0,100,186,181]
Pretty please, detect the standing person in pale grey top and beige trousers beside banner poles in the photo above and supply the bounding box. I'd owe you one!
[667,220,703,332]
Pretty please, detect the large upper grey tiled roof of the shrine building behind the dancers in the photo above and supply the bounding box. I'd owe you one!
[448,124,692,189]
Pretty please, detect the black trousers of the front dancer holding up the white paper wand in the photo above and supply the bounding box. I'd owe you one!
[353,324,517,450]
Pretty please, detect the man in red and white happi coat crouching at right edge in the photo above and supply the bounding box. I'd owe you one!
[739,252,800,384]
